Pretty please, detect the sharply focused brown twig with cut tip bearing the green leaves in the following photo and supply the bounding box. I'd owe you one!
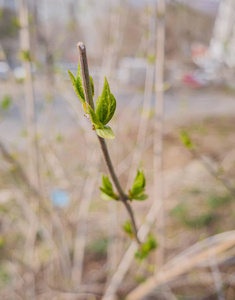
[77,42,141,244]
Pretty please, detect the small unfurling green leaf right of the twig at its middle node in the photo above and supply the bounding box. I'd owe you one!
[129,170,148,201]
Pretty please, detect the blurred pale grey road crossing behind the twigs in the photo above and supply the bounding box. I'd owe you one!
[0,78,235,145]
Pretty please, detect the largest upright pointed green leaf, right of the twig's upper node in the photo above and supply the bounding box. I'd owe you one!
[95,77,116,125]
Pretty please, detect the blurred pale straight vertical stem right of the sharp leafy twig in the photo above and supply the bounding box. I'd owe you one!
[153,0,166,270]
